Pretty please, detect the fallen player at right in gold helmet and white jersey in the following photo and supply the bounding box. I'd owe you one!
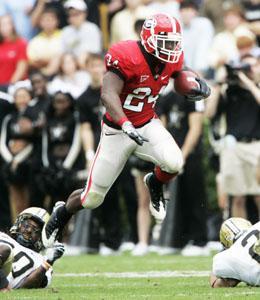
[210,218,260,288]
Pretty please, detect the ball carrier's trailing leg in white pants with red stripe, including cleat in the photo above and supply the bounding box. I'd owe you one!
[42,125,136,247]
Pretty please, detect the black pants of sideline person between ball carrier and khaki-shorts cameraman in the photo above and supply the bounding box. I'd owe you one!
[171,153,207,248]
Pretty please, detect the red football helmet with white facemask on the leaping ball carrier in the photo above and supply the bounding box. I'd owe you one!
[141,13,182,63]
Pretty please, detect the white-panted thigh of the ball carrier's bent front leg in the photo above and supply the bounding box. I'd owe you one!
[135,119,183,173]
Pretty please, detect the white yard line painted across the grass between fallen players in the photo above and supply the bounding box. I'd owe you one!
[55,270,210,278]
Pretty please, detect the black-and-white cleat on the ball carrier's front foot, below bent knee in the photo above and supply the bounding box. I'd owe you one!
[144,173,166,223]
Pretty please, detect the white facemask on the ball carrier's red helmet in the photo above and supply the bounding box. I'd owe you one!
[147,32,182,63]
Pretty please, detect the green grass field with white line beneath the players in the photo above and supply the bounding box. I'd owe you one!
[0,254,260,300]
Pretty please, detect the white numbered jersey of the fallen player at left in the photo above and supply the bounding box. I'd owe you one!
[0,232,52,289]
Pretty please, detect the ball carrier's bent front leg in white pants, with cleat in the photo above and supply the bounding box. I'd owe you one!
[135,119,183,222]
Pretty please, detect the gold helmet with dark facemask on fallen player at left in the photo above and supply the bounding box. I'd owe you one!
[10,207,50,252]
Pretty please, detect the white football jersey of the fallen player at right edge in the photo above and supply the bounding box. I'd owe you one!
[212,222,260,286]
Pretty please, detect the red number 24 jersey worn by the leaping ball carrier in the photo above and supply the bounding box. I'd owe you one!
[105,40,183,127]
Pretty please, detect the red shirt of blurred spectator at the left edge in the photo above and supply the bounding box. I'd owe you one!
[0,38,27,84]
